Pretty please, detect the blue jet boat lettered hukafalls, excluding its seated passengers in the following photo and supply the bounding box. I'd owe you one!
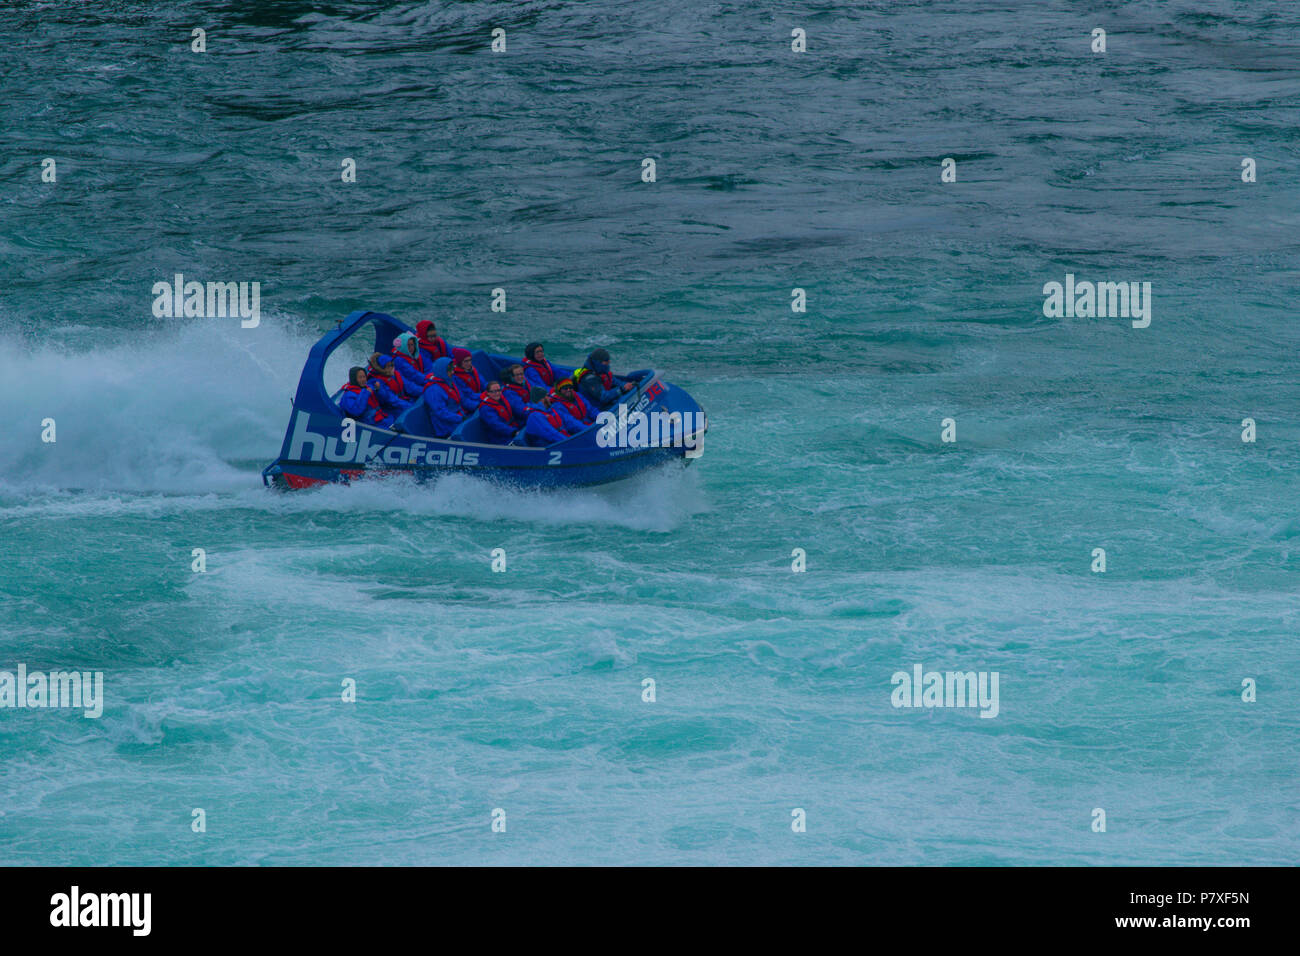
[261,311,709,489]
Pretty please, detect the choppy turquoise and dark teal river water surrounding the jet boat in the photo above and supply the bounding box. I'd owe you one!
[0,0,1300,864]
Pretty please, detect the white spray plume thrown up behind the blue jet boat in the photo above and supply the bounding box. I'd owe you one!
[0,317,312,496]
